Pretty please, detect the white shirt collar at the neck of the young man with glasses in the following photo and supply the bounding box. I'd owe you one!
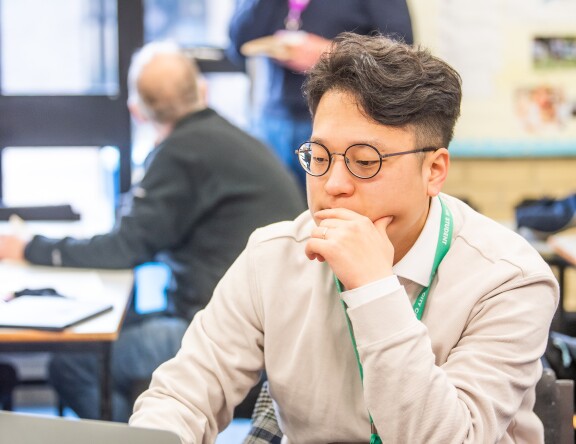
[392,196,442,287]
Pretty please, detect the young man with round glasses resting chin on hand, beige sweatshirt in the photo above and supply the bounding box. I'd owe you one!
[131,34,558,443]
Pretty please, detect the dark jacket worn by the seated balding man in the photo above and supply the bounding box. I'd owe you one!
[25,109,305,319]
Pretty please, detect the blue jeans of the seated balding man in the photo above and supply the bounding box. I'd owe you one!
[49,316,189,422]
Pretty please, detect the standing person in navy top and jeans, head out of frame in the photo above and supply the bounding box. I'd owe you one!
[229,0,413,188]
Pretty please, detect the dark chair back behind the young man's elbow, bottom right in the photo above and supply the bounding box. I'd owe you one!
[534,368,574,444]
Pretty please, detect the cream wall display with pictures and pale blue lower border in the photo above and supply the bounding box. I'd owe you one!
[411,0,576,157]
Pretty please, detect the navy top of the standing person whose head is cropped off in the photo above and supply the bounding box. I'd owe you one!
[228,0,413,120]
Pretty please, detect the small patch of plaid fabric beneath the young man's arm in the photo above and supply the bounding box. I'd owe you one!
[243,381,282,444]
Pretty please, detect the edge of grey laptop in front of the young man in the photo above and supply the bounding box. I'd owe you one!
[0,411,181,444]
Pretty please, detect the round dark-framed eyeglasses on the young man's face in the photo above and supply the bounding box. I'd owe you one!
[295,142,439,179]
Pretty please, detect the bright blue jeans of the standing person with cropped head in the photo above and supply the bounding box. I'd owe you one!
[252,115,312,190]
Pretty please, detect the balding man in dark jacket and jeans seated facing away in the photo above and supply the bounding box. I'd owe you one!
[0,43,304,421]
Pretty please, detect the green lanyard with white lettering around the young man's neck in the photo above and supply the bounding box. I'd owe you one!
[334,199,453,444]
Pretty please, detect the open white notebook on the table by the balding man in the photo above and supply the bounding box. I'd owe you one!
[0,296,112,330]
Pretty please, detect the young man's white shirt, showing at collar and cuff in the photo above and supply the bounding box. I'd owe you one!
[342,196,442,308]
